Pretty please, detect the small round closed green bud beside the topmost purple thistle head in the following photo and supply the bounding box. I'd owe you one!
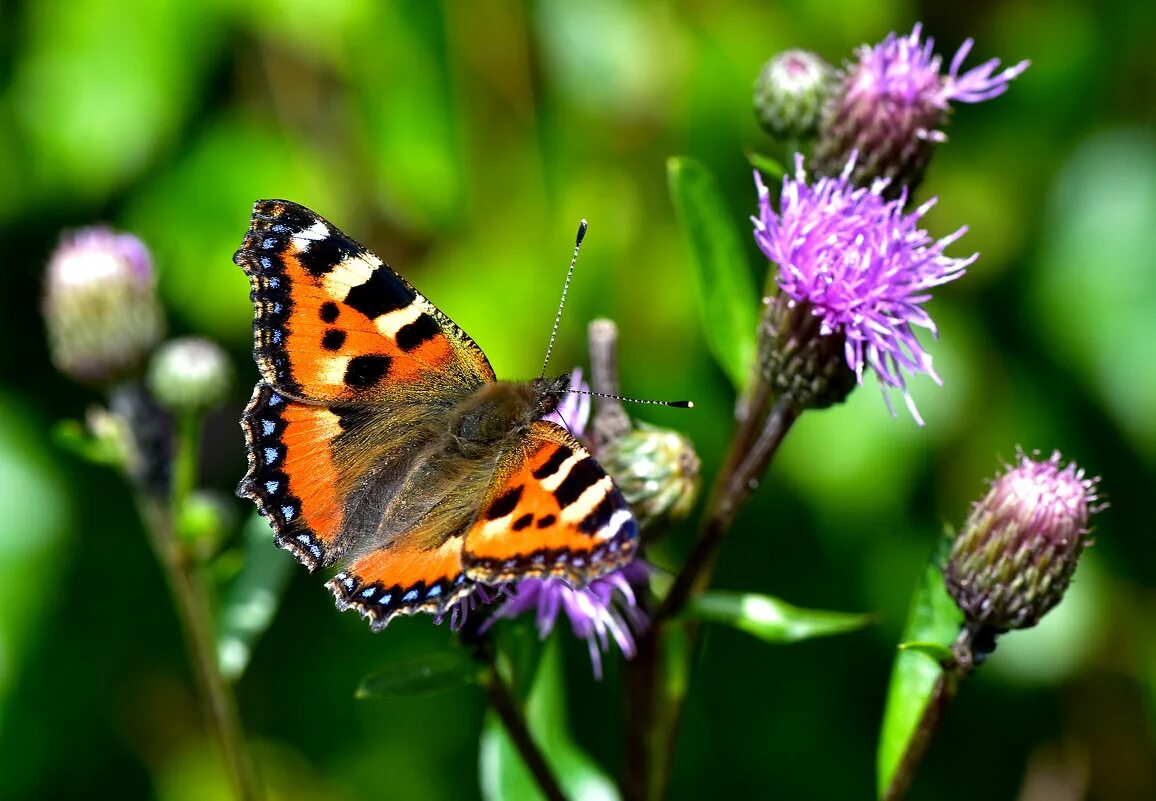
[755,50,835,140]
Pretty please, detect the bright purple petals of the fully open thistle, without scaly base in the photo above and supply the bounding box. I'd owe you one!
[751,156,978,425]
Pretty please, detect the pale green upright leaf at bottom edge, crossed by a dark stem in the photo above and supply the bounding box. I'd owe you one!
[479,638,618,801]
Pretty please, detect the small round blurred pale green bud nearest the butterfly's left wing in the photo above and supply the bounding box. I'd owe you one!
[148,336,232,414]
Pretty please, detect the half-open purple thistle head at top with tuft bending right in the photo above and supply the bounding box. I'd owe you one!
[813,23,1029,198]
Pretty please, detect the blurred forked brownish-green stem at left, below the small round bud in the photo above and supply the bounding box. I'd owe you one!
[138,406,261,801]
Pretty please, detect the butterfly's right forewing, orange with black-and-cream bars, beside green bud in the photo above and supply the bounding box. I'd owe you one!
[464,421,638,586]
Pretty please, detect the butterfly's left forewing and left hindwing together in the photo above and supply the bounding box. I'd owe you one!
[235,200,494,584]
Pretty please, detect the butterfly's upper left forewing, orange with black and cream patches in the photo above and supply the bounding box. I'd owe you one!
[234,200,494,403]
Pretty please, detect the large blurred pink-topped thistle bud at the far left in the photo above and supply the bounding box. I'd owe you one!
[44,228,163,384]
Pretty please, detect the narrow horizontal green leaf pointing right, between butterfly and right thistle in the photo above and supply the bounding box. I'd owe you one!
[689,592,873,644]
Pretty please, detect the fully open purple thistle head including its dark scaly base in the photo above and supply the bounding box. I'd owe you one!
[751,156,978,424]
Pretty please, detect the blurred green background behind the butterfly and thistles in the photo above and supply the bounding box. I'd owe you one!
[0,0,1156,801]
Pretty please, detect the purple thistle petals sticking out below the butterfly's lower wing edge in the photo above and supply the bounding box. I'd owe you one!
[482,561,650,678]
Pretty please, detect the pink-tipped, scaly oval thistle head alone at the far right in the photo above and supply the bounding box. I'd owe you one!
[943,451,1101,632]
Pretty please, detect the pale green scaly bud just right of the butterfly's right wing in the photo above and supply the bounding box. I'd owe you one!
[598,423,702,528]
